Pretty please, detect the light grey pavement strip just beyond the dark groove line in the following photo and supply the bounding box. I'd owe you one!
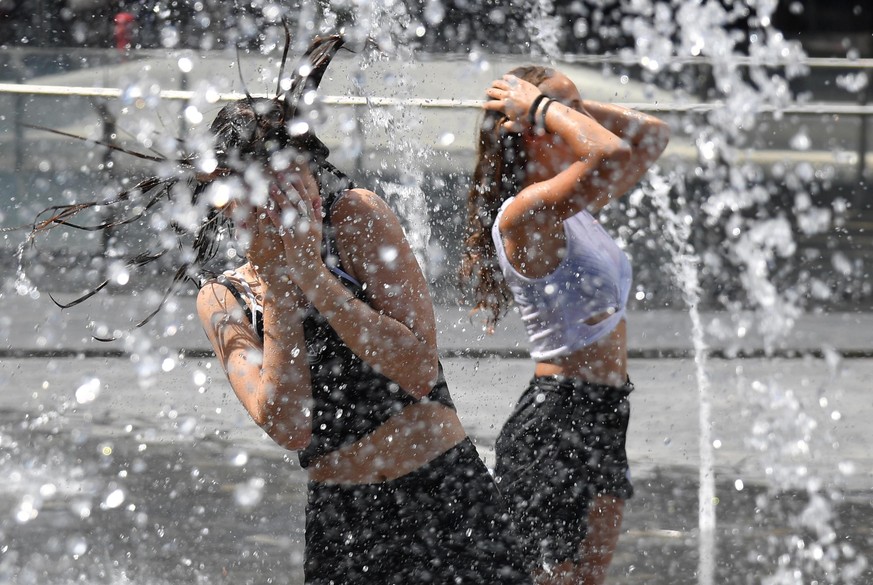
[0,290,873,357]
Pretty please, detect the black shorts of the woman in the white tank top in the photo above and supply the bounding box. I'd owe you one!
[495,376,633,566]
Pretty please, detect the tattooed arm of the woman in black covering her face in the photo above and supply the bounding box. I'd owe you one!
[197,283,312,450]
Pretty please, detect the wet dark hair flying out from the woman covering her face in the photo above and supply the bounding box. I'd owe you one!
[19,34,353,341]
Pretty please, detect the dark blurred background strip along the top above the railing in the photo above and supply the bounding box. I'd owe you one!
[0,0,873,57]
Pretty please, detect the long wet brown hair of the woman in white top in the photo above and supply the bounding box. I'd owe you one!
[458,65,555,327]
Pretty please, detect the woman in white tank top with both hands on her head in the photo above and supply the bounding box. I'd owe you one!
[461,66,669,585]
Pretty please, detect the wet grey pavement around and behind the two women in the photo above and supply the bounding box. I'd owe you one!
[0,296,873,585]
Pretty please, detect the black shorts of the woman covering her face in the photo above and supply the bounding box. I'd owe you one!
[305,439,531,585]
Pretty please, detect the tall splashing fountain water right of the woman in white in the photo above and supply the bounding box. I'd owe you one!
[628,0,863,585]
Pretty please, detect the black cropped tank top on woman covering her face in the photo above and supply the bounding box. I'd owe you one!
[217,189,455,468]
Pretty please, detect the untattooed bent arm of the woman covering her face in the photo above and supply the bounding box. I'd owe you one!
[275,189,439,398]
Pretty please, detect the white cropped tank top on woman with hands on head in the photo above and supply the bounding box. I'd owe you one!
[491,198,632,361]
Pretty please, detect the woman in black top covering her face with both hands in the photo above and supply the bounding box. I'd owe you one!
[197,37,530,585]
